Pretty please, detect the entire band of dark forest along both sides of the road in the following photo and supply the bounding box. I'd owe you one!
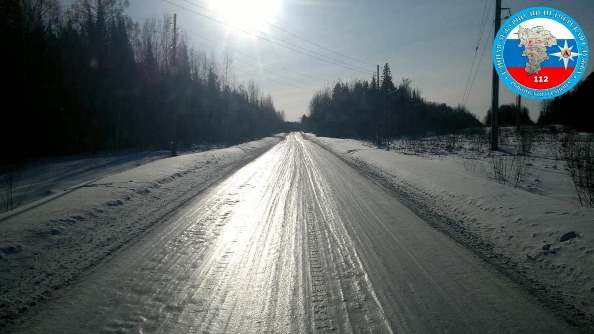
[0,0,594,165]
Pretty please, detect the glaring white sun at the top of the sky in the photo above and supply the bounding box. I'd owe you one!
[209,0,281,33]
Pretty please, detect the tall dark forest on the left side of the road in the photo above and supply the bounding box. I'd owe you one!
[0,0,283,163]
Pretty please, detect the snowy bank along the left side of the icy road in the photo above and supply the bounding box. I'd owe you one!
[0,135,284,328]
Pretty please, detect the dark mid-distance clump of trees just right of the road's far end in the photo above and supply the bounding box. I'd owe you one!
[302,64,482,142]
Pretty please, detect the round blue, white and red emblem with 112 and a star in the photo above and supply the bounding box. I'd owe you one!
[493,7,588,99]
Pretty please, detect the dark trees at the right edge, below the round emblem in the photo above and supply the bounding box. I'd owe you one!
[538,73,594,132]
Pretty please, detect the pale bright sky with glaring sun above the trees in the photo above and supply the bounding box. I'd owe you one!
[73,0,594,120]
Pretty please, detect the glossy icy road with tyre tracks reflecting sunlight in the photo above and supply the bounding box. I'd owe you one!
[16,134,569,333]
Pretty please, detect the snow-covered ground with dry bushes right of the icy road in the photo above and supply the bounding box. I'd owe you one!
[308,135,594,326]
